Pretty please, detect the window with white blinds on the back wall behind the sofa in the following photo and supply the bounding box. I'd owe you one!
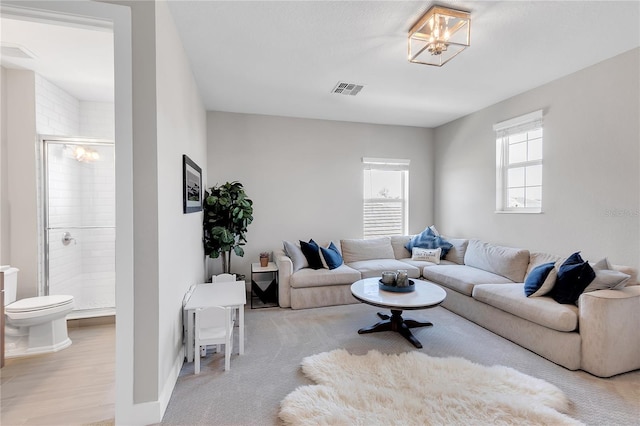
[362,158,409,239]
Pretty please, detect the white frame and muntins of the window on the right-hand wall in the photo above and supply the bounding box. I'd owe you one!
[493,110,544,214]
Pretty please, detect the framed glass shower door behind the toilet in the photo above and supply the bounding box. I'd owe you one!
[44,139,116,317]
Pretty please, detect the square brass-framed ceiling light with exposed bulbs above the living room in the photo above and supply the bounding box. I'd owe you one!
[409,6,471,67]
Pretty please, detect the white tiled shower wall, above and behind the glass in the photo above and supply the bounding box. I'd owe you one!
[36,75,115,310]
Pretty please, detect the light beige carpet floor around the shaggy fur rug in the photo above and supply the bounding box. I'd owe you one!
[162,304,640,425]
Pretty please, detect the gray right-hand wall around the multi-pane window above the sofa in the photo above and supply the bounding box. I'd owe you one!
[435,49,640,267]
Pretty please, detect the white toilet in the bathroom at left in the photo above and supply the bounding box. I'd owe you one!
[0,266,73,358]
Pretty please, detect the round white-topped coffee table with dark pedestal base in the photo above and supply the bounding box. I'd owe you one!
[351,277,447,348]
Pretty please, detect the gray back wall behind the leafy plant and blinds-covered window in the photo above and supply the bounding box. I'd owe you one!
[206,112,433,276]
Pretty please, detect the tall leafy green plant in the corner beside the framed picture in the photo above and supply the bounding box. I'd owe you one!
[203,182,253,274]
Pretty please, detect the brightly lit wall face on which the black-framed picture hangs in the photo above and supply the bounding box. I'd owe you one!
[154,2,207,413]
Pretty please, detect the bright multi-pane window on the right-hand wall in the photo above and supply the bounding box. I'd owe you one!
[493,111,542,213]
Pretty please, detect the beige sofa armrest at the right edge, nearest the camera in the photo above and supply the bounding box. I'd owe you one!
[579,285,640,377]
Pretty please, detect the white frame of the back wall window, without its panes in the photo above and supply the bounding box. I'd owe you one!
[362,157,410,239]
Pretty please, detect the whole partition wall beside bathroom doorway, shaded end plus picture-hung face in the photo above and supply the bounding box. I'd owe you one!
[116,1,207,412]
